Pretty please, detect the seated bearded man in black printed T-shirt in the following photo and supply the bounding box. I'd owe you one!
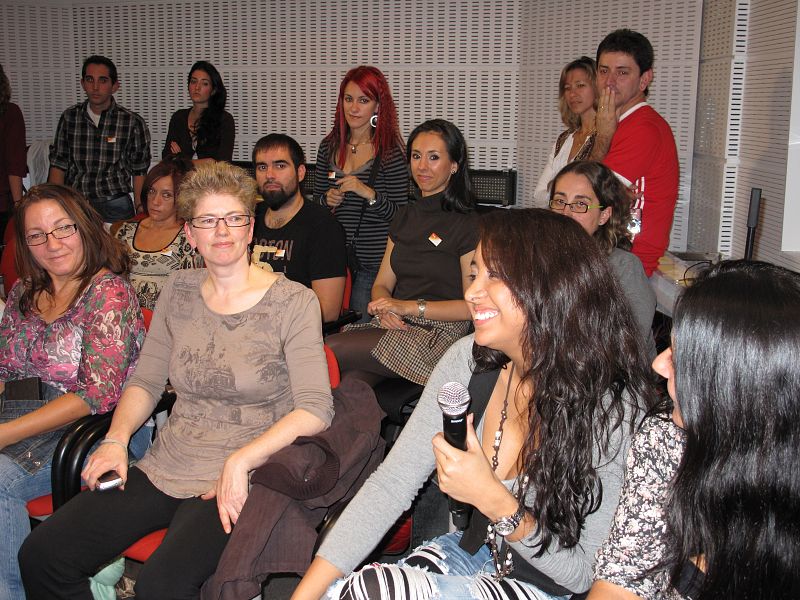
[253,133,347,321]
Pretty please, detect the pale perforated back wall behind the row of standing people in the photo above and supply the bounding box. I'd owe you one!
[0,0,702,248]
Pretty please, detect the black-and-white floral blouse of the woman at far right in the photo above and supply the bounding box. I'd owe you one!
[594,417,685,600]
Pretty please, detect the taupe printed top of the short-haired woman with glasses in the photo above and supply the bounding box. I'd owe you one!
[133,269,333,498]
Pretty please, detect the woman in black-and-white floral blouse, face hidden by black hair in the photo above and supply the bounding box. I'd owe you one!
[589,261,800,600]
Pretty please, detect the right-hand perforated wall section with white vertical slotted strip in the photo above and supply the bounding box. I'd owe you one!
[689,0,800,269]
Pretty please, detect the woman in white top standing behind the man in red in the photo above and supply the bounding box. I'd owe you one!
[533,56,597,208]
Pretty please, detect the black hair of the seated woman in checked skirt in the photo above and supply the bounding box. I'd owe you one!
[406,119,477,213]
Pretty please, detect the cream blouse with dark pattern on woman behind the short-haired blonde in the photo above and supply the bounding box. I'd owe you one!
[116,221,199,310]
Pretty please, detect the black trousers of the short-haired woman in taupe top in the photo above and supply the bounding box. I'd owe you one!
[19,467,229,600]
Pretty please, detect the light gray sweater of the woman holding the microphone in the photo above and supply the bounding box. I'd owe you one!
[318,335,630,592]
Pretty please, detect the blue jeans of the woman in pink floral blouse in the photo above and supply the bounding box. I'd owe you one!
[0,454,50,600]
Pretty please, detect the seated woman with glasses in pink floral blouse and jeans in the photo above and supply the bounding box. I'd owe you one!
[0,184,144,600]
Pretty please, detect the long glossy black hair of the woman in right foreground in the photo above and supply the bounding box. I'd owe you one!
[666,261,800,600]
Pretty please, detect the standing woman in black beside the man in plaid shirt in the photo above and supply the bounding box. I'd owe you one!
[161,60,236,164]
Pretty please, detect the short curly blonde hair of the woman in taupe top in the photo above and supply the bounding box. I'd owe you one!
[178,162,259,222]
